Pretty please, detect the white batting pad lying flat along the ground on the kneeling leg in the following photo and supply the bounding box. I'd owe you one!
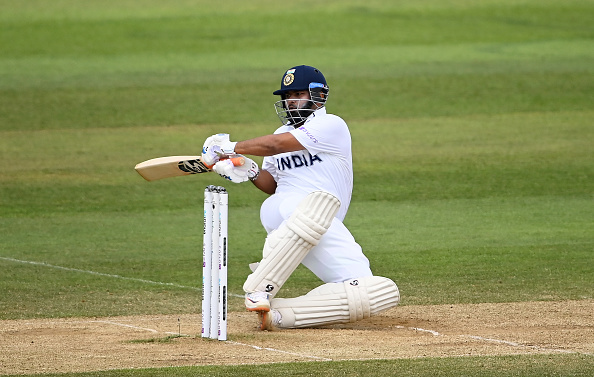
[270,276,400,328]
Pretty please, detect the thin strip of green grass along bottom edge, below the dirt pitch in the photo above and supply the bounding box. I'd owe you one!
[5,355,594,377]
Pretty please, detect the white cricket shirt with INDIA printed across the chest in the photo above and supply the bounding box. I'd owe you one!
[262,107,353,221]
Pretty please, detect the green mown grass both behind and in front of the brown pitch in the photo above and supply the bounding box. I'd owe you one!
[0,0,594,376]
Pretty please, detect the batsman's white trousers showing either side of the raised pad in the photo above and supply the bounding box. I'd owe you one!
[260,193,373,283]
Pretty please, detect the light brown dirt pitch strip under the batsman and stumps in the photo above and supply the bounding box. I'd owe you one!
[0,300,594,374]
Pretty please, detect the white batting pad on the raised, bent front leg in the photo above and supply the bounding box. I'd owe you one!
[243,191,340,297]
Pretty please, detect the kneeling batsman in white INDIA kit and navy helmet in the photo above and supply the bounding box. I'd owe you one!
[202,65,400,330]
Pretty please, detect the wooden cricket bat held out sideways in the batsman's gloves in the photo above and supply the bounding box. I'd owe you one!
[134,156,245,181]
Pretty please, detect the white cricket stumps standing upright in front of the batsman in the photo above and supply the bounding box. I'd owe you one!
[202,185,229,340]
